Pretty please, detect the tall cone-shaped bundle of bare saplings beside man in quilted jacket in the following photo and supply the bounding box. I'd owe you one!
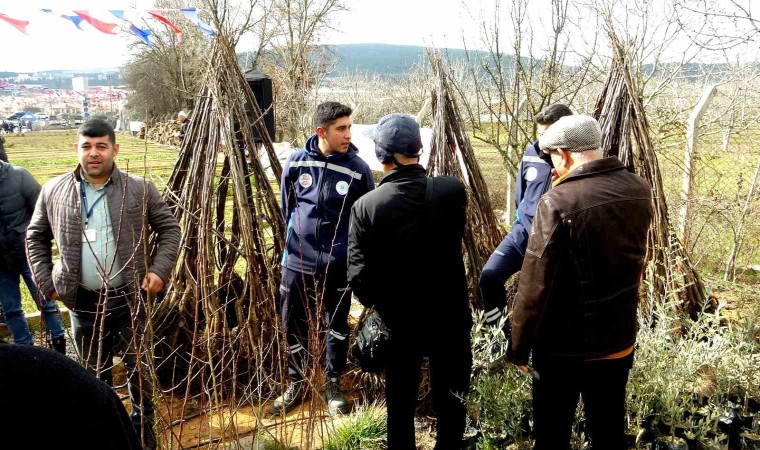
[152,30,285,418]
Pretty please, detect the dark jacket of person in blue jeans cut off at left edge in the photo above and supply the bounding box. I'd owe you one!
[0,161,41,270]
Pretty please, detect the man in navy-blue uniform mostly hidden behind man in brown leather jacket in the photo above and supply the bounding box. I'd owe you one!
[478,103,573,325]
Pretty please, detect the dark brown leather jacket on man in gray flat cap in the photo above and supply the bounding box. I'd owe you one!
[509,156,652,364]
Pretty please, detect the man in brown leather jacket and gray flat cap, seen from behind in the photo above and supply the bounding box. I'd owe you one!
[508,115,652,450]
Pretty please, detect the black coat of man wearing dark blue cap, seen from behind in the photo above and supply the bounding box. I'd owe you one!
[348,164,470,333]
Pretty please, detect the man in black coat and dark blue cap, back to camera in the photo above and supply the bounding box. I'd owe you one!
[348,114,472,450]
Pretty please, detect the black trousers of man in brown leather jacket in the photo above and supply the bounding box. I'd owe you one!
[533,354,633,450]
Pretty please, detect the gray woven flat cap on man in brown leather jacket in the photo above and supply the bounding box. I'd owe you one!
[538,115,602,152]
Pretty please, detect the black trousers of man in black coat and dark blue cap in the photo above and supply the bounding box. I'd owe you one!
[385,321,472,450]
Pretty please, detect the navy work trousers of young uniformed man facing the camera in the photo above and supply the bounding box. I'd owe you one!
[280,269,351,381]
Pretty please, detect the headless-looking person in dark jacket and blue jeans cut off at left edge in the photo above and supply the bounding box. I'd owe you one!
[0,161,66,354]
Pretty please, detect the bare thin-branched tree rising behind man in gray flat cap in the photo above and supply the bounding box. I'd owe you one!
[460,0,601,220]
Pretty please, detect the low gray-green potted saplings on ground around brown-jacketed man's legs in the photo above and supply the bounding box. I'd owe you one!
[468,304,760,450]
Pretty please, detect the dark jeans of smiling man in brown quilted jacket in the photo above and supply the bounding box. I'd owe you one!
[69,287,154,440]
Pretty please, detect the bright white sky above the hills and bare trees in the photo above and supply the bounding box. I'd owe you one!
[0,0,757,72]
